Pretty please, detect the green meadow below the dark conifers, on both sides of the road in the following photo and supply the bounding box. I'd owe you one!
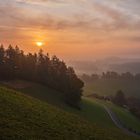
[1,81,140,139]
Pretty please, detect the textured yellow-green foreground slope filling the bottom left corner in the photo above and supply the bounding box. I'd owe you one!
[0,87,136,140]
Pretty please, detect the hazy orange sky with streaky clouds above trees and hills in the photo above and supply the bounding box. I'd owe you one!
[0,0,140,59]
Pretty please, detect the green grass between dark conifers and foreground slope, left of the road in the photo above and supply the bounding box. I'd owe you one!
[20,84,116,128]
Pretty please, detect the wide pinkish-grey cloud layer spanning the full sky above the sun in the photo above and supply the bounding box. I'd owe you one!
[0,0,140,31]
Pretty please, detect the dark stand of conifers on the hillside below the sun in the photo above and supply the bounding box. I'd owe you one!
[0,45,84,107]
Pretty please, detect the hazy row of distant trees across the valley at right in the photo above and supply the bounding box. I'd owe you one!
[81,71,140,82]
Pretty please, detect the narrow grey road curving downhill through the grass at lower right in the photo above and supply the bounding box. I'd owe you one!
[104,105,140,137]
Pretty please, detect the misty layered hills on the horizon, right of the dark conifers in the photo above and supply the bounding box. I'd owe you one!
[68,57,140,74]
